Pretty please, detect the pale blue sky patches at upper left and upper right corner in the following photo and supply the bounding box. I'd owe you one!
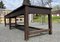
[0,0,60,10]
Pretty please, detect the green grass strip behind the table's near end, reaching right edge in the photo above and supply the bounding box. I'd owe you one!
[33,16,60,23]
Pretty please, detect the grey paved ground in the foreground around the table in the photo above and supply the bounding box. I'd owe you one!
[0,23,60,42]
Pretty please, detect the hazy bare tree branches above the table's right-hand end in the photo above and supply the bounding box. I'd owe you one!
[30,0,52,6]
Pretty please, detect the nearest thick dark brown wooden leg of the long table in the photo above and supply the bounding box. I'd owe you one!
[24,6,29,40]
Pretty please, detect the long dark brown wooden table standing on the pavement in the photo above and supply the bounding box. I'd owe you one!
[4,0,52,40]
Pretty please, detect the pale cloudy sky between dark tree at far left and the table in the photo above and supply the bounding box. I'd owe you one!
[3,0,23,10]
